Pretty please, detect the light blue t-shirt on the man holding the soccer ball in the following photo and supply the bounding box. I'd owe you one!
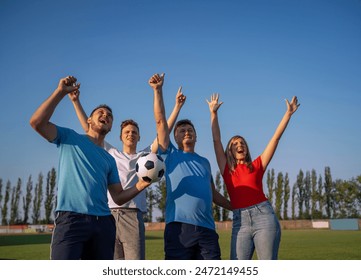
[52,126,120,216]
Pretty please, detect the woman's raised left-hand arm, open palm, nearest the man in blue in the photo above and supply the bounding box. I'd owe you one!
[207,93,227,174]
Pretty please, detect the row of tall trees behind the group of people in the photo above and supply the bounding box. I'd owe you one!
[0,167,361,225]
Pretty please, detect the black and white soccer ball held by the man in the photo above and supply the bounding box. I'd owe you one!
[135,153,165,183]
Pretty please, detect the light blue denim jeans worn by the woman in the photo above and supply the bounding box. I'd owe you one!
[231,201,281,260]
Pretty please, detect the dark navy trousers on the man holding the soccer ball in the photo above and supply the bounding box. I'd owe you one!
[51,211,115,260]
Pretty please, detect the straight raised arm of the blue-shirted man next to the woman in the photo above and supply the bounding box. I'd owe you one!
[148,74,169,151]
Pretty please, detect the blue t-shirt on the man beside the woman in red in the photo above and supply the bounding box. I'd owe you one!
[159,143,215,230]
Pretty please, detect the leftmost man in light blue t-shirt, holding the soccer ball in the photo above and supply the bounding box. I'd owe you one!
[30,76,150,260]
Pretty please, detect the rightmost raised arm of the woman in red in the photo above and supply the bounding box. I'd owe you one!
[261,96,300,170]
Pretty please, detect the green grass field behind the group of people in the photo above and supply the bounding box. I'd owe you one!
[0,230,361,260]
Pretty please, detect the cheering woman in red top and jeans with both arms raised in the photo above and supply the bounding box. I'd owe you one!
[207,94,300,260]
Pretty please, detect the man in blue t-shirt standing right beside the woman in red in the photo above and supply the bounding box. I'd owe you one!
[149,74,231,260]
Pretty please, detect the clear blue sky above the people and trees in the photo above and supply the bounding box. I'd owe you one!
[0,0,361,189]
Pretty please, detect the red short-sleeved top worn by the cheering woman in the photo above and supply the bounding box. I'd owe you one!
[223,156,267,209]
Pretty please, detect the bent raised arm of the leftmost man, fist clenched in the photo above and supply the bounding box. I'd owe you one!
[30,76,80,141]
